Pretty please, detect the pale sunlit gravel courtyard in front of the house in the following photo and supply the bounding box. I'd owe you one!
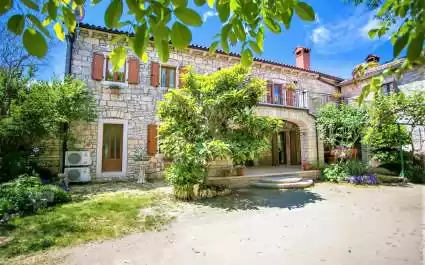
[30,184,425,265]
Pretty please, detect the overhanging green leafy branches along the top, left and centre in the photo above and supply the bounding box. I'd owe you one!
[0,0,315,69]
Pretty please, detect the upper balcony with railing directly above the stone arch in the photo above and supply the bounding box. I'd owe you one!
[259,89,336,114]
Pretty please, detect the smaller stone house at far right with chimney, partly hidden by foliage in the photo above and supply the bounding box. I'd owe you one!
[339,55,425,157]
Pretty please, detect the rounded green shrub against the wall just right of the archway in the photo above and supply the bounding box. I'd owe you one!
[317,103,367,148]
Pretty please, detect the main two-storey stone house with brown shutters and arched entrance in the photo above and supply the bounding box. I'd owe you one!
[56,23,343,180]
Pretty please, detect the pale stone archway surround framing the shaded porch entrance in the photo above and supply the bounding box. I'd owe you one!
[255,106,324,163]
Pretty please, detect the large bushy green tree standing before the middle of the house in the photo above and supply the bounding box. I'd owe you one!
[158,66,282,198]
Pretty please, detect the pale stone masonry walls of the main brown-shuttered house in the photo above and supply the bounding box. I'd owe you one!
[63,26,337,179]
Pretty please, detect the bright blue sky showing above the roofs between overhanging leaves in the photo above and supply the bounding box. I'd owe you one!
[39,0,392,79]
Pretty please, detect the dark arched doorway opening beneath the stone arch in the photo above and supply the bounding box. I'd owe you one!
[271,121,301,166]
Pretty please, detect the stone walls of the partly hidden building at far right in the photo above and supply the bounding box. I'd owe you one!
[341,59,425,153]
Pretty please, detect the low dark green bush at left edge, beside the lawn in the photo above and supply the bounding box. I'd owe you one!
[0,175,71,222]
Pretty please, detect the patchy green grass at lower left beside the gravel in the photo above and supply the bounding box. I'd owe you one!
[0,190,171,260]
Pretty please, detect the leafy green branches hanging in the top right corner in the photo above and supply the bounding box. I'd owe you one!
[349,0,425,103]
